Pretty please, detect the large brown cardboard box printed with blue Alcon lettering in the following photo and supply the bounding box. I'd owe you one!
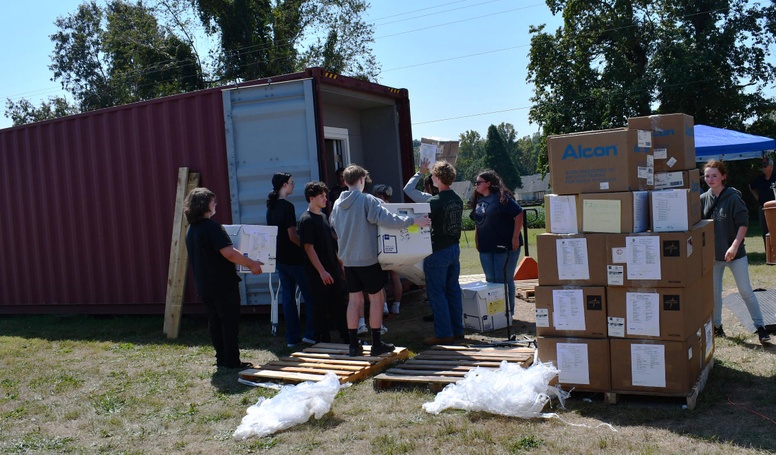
[547,128,654,194]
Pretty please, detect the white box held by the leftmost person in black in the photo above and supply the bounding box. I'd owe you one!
[224,224,278,273]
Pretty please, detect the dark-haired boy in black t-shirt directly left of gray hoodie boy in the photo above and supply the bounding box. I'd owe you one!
[297,182,349,343]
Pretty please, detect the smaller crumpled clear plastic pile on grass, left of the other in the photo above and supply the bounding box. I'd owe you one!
[232,373,342,439]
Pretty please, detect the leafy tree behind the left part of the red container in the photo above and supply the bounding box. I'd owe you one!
[6,0,204,125]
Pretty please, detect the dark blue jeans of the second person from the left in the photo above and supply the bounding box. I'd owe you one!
[277,263,315,344]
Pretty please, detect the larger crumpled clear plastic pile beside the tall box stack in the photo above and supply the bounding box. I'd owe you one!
[423,361,569,418]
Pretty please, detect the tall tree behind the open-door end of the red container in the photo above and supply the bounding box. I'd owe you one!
[190,0,379,81]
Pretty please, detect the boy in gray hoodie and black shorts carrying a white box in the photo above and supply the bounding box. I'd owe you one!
[331,164,431,357]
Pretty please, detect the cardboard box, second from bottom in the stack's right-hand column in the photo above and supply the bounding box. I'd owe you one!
[606,276,714,341]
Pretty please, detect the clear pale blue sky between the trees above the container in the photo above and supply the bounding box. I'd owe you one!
[0,0,562,140]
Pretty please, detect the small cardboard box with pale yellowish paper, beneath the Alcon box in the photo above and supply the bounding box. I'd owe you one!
[579,191,652,233]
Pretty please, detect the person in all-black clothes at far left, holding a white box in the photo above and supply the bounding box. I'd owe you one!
[183,188,262,368]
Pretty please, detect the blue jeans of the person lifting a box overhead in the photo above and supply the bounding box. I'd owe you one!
[423,245,463,338]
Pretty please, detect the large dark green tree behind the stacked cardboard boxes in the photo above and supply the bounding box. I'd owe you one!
[527,0,776,174]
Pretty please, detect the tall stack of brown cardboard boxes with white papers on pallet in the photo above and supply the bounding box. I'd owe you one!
[535,114,714,400]
